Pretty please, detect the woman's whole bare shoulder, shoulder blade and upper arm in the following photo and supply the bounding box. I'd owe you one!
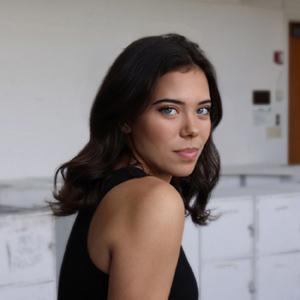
[89,176,185,300]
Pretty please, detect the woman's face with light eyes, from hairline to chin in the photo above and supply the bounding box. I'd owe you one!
[129,67,211,182]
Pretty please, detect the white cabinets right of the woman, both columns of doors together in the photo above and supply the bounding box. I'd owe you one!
[199,184,300,300]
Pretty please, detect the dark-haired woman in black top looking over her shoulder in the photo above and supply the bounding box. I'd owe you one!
[52,34,222,300]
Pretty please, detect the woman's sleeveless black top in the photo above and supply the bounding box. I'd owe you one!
[58,166,198,300]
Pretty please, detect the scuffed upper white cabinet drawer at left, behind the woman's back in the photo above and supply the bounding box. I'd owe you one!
[0,212,55,286]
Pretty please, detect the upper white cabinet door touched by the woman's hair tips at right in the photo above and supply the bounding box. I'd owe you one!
[200,197,253,260]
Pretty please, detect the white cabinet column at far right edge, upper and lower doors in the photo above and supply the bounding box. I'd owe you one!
[255,192,300,300]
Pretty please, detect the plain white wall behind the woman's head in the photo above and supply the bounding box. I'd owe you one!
[0,0,300,179]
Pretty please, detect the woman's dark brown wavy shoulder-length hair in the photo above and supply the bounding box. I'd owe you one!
[50,34,222,225]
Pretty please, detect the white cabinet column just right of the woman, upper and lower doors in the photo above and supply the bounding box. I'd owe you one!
[200,196,254,300]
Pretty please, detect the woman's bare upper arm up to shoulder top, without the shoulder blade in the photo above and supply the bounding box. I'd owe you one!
[108,179,184,300]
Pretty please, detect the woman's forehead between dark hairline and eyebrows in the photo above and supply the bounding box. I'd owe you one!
[151,67,210,102]
